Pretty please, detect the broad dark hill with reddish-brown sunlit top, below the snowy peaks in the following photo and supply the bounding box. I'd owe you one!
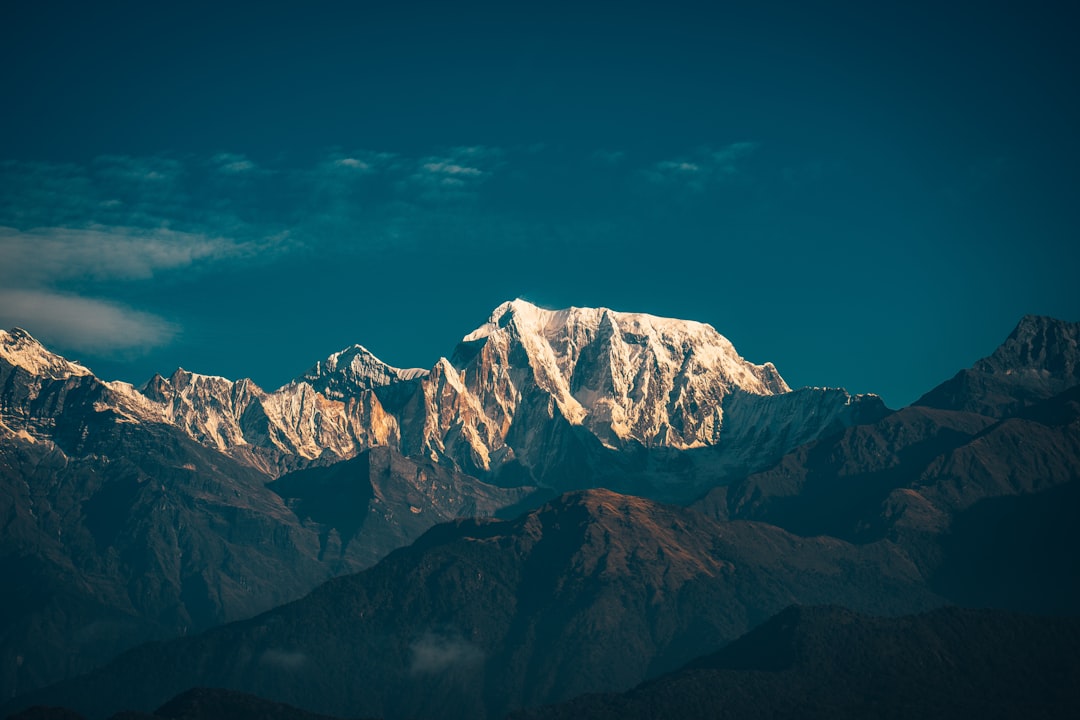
[6,490,939,718]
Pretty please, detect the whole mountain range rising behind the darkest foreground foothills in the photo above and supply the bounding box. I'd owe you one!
[0,300,1080,718]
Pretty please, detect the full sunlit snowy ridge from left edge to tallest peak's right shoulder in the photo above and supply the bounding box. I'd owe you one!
[0,300,883,476]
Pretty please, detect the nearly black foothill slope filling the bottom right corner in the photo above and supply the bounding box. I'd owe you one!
[514,608,1080,720]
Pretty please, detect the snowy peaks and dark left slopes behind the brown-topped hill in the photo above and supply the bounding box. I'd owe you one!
[0,300,885,694]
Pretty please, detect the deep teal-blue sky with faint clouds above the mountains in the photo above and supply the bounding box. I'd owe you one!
[0,2,1080,407]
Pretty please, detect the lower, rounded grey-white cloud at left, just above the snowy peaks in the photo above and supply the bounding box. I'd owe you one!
[0,289,179,355]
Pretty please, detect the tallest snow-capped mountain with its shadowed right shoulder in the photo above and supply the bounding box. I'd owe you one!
[401,300,886,490]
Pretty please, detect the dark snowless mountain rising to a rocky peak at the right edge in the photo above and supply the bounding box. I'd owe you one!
[694,318,1080,612]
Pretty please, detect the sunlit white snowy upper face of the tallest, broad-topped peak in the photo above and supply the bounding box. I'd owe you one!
[455,300,791,448]
